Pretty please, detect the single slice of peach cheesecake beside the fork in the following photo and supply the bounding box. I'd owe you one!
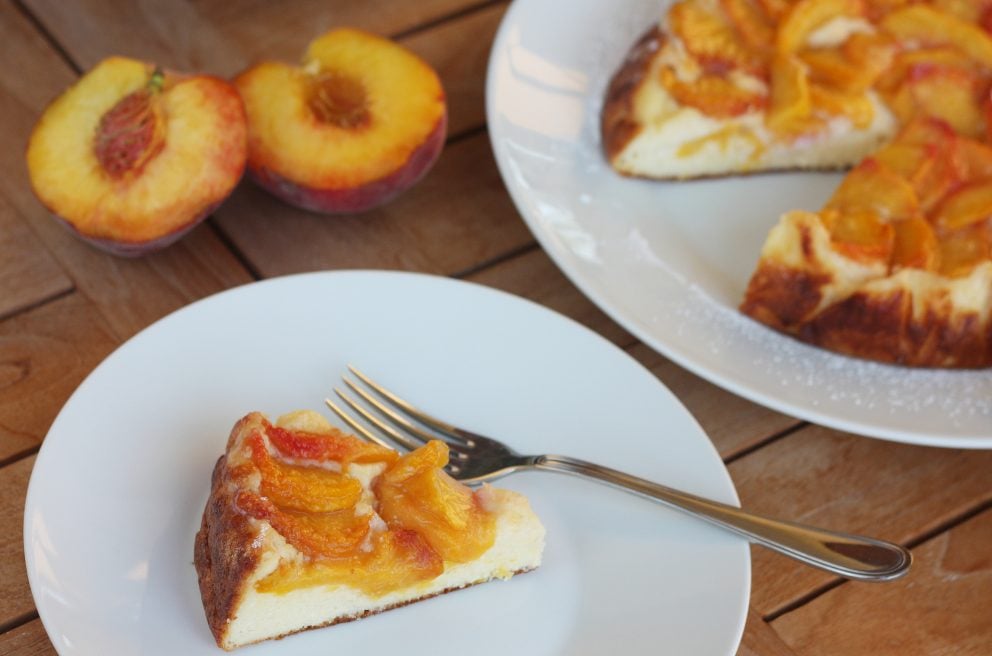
[194,411,544,650]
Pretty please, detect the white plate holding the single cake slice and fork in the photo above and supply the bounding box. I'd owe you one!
[24,272,750,656]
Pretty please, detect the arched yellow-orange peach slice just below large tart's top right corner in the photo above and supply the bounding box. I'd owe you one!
[880,4,992,69]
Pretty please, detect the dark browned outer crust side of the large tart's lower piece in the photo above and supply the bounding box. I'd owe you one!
[740,261,992,369]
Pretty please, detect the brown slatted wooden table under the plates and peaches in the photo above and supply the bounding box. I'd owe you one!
[0,0,992,656]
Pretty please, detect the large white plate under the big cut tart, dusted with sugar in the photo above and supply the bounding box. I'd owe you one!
[486,0,992,448]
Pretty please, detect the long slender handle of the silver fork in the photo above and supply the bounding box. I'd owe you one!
[531,455,912,581]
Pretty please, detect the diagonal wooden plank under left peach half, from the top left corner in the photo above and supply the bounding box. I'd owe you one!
[0,3,251,338]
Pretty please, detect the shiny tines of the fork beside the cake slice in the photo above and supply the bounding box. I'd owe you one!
[325,365,471,472]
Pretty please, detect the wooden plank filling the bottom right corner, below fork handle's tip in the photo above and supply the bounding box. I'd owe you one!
[772,508,992,656]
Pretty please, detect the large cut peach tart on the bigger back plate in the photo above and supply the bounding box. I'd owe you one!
[601,0,992,367]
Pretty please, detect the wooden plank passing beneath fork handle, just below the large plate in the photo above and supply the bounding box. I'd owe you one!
[729,426,992,617]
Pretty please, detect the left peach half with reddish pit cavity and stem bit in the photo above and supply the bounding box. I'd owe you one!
[27,57,247,256]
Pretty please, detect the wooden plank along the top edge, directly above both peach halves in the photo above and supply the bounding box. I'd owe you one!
[25,0,500,77]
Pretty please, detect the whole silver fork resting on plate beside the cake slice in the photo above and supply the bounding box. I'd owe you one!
[326,366,912,581]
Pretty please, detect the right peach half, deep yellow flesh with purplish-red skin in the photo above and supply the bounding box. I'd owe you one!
[234,28,448,214]
